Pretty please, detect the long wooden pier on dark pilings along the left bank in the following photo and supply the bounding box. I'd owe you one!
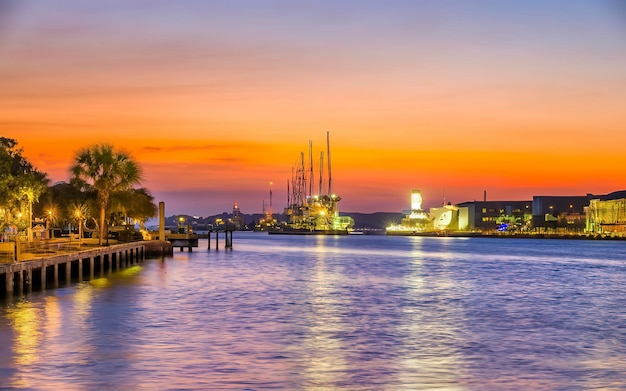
[0,242,149,296]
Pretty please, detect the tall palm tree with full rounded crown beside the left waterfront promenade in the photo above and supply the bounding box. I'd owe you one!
[70,144,141,245]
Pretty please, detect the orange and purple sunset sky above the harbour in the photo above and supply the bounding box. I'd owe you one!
[0,0,626,216]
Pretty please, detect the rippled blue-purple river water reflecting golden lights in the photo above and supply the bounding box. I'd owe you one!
[0,232,626,391]
